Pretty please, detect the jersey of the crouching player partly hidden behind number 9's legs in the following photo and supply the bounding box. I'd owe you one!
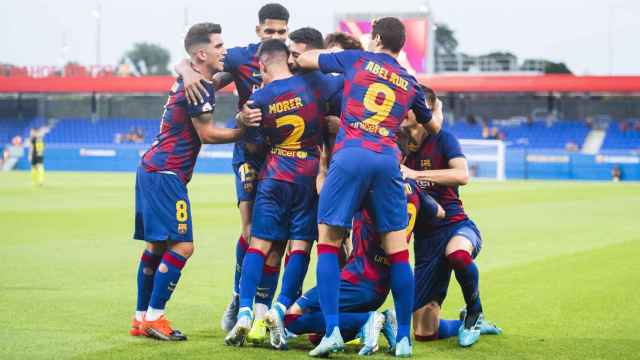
[340,179,438,295]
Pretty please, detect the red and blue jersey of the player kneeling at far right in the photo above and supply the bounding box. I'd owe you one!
[405,130,468,234]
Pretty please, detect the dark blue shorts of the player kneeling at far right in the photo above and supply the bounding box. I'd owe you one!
[413,220,482,310]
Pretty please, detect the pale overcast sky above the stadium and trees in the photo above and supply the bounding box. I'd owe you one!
[0,0,640,75]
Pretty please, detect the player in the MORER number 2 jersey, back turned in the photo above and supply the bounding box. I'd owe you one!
[225,40,341,346]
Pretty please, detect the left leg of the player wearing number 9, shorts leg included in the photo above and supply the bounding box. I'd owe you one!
[309,148,372,356]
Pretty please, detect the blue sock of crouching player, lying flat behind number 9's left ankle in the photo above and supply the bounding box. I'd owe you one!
[285,311,369,339]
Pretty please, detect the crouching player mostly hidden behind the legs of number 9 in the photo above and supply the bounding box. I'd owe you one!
[285,176,445,355]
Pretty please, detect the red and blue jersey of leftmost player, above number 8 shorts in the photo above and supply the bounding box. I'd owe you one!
[140,78,216,184]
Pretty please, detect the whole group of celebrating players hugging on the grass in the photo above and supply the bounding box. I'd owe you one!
[130,4,501,357]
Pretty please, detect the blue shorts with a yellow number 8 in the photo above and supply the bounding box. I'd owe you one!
[133,167,193,242]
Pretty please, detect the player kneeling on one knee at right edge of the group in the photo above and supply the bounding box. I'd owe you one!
[402,88,501,347]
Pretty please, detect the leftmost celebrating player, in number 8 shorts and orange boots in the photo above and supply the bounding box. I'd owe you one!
[130,23,244,340]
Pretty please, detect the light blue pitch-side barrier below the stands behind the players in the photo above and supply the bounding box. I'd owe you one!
[10,144,640,181]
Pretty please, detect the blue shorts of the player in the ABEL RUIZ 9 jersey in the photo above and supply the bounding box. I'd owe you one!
[318,147,407,233]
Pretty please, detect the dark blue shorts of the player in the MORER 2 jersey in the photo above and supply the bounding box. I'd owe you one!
[251,179,318,241]
